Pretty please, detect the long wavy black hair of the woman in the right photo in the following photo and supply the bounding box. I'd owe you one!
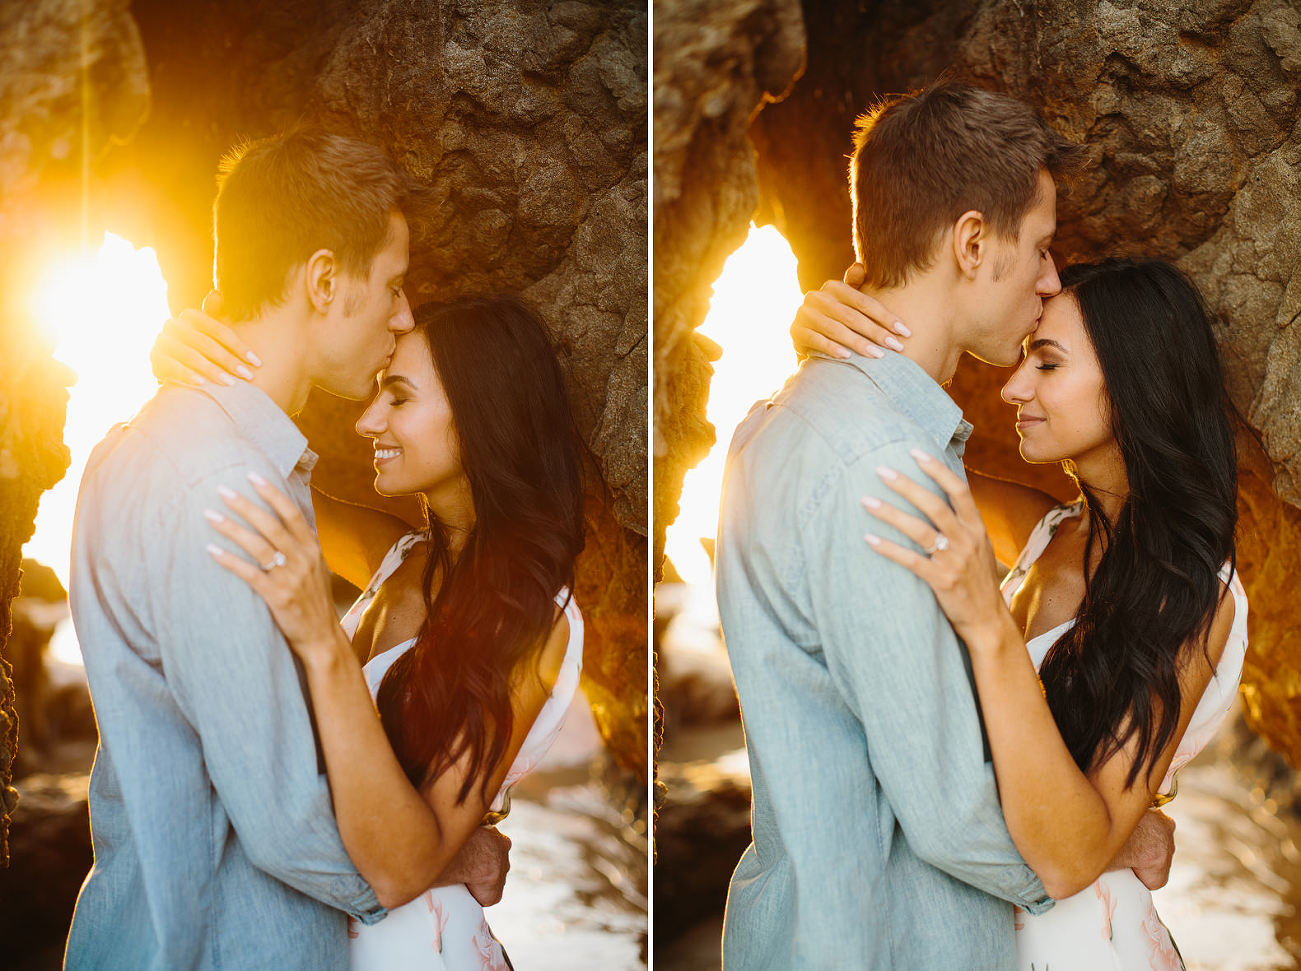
[1039,259,1237,786]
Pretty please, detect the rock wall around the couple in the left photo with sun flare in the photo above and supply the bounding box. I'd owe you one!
[0,0,648,842]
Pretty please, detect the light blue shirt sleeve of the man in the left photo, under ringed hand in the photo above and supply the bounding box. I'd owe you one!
[148,463,386,923]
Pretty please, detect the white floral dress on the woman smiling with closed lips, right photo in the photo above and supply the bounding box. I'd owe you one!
[1003,502,1246,971]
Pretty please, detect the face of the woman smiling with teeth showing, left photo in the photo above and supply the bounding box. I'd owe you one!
[356,329,470,508]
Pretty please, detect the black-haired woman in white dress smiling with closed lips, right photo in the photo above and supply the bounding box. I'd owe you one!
[792,260,1246,971]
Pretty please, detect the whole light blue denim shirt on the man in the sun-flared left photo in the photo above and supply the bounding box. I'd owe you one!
[65,383,385,971]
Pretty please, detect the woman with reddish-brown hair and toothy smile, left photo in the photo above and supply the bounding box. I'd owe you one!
[156,297,583,971]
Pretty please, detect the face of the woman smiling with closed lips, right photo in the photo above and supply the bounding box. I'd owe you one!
[1003,293,1119,465]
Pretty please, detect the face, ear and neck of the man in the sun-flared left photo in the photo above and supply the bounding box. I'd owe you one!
[317,212,415,398]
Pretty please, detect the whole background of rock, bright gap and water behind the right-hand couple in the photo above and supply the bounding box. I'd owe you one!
[652,0,1301,971]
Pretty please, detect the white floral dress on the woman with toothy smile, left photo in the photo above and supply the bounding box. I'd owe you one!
[342,532,583,971]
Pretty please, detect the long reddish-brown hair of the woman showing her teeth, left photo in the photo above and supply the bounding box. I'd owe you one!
[376,297,583,802]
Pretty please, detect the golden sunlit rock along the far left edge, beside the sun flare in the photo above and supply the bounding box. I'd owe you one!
[0,0,148,866]
